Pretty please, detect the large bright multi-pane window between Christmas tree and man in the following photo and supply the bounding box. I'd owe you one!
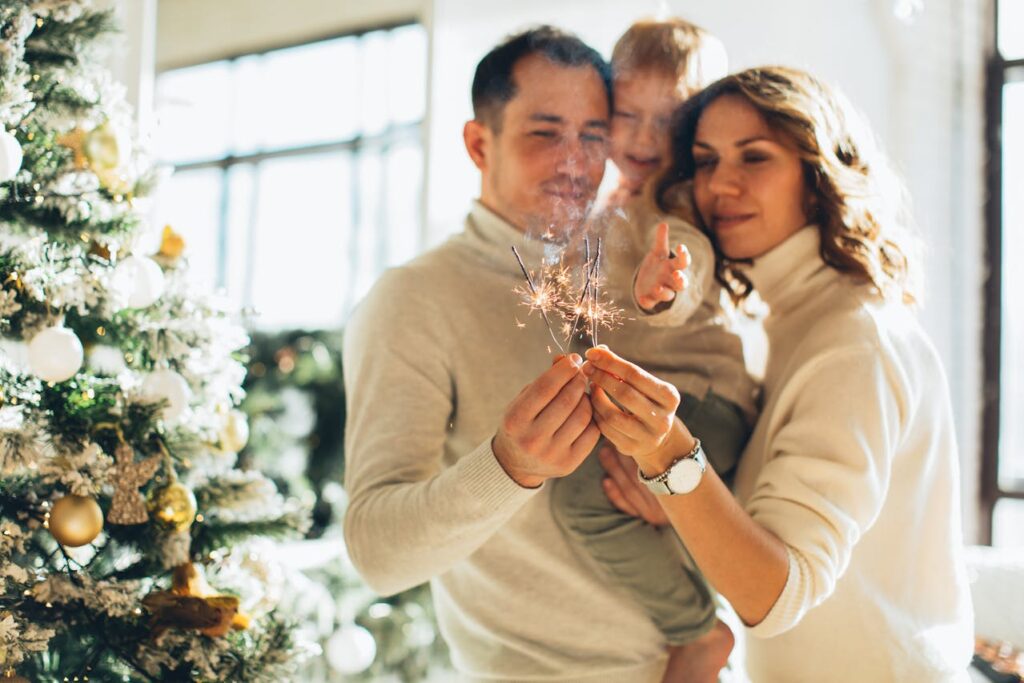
[154,24,427,330]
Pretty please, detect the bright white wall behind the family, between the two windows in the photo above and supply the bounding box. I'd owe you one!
[425,0,984,538]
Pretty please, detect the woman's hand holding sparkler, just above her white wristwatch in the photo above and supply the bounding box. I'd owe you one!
[583,346,679,459]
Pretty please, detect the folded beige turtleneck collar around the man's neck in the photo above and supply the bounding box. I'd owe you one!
[466,200,581,272]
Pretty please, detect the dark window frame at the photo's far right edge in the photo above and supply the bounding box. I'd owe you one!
[979,0,1024,545]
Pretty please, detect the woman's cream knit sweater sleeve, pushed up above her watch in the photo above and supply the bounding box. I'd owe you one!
[745,345,906,638]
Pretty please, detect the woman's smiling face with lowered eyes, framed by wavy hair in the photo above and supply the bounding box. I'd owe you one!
[692,95,808,259]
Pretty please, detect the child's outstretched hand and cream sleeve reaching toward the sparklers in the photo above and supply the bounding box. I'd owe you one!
[633,217,715,327]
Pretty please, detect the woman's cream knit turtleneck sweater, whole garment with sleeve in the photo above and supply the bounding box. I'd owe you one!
[735,227,973,683]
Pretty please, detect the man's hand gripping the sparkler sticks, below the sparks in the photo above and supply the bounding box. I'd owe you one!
[492,353,601,488]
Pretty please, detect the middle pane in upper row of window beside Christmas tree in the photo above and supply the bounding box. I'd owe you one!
[233,38,358,154]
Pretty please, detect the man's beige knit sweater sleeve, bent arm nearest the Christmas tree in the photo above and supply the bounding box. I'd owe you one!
[344,274,538,596]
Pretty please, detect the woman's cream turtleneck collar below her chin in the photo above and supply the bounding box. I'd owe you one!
[742,225,829,312]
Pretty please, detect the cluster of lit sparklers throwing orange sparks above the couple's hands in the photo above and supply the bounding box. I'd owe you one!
[512,238,623,353]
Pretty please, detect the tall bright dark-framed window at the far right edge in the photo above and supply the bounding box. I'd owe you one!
[982,0,1024,547]
